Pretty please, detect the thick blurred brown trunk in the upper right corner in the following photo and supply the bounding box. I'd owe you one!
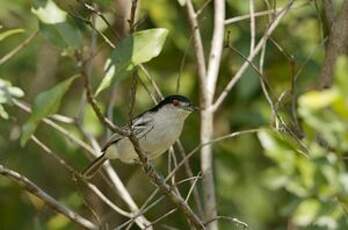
[320,0,348,88]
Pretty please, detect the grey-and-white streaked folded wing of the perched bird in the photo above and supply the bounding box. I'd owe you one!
[101,114,153,152]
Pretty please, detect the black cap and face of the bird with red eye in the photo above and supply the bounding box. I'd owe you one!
[150,95,197,112]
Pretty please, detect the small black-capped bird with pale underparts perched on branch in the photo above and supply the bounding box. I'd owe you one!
[83,95,197,178]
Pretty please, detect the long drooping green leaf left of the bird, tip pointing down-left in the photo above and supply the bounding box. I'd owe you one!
[21,76,77,146]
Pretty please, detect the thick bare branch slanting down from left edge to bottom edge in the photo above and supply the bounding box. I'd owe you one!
[0,165,98,229]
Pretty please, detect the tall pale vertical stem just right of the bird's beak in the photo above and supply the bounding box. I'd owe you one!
[200,0,225,230]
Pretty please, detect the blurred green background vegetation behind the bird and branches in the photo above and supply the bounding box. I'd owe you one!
[0,0,348,229]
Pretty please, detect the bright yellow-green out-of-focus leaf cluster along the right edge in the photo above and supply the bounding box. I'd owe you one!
[259,57,348,229]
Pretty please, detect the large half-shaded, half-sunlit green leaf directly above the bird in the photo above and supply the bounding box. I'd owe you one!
[97,28,168,94]
